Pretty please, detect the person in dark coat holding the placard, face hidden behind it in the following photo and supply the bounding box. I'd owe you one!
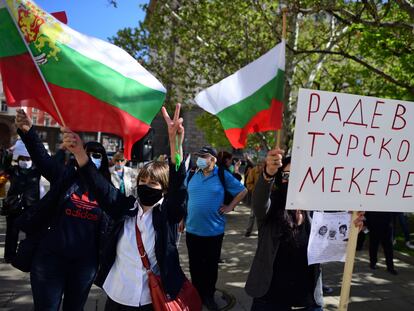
[245,149,363,311]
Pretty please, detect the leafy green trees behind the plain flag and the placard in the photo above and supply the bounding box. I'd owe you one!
[112,0,414,148]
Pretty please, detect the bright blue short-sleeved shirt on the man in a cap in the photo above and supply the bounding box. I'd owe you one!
[186,167,245,236]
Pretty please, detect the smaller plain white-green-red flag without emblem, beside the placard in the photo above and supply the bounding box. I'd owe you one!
[195,40,285,149]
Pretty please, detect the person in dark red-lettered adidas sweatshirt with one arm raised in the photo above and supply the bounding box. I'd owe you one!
[16,110,110,311]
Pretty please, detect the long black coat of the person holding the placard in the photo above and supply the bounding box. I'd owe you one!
[245,175,323,306]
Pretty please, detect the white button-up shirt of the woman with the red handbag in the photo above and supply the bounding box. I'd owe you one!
[103,199,162,307]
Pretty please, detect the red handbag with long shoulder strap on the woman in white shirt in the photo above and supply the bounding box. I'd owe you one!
[135,221,202,311]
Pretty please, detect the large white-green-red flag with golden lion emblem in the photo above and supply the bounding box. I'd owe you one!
[0,0,166,158]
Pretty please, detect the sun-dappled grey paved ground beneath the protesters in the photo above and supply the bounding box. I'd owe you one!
[0,207,414,311]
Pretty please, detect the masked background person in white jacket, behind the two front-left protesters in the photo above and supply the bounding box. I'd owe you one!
[109,151,137,197]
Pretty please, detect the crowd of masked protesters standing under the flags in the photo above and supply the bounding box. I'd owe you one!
[0,105,413,311]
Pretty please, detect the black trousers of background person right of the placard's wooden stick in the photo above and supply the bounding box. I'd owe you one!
[369,226,394,269]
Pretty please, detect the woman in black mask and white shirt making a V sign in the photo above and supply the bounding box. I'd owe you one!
[63,105,187,311]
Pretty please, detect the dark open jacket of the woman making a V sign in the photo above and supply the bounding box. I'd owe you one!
[80,161,187,298]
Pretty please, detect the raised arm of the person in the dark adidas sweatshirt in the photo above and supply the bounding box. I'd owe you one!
[15,109,65,182]
